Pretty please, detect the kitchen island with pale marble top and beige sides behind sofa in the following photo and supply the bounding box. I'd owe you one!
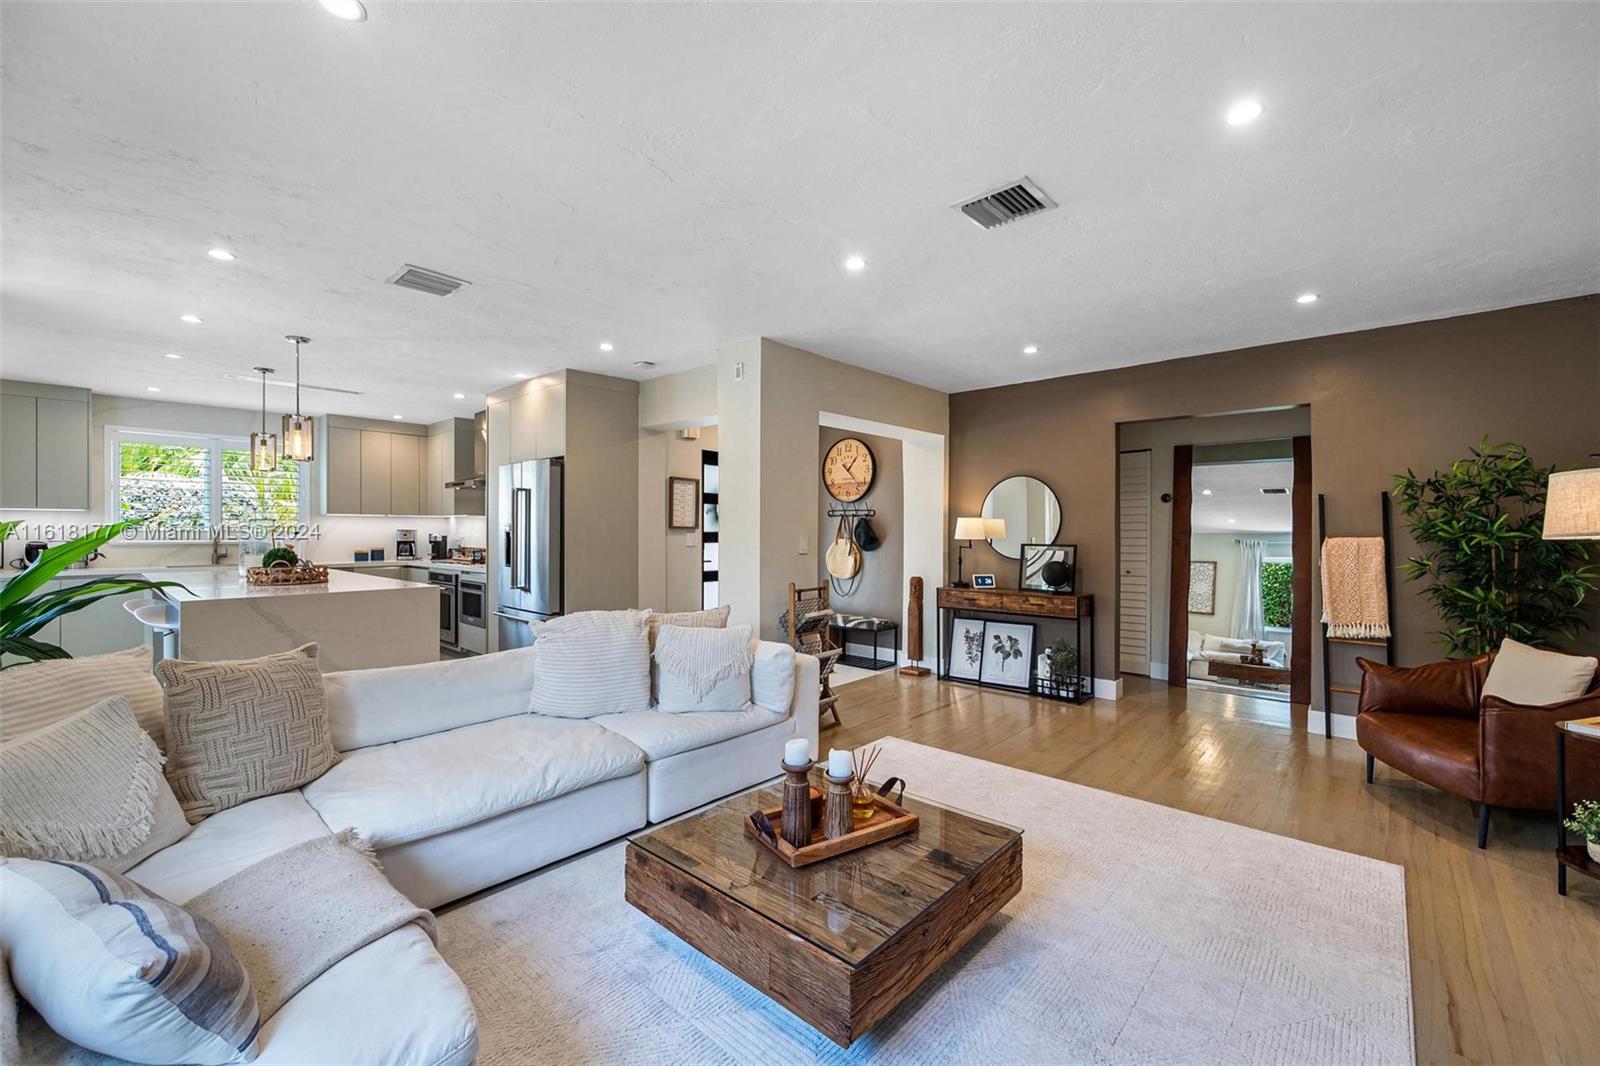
[154,567,438,672]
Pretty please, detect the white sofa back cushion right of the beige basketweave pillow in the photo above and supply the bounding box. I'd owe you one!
[322,647,536,752]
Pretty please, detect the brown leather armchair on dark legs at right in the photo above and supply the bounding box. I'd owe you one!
[1355,655,1600,848]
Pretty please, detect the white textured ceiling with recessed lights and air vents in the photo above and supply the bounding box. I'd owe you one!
[0,0,1600,419]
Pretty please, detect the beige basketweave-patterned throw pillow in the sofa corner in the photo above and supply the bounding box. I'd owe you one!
[155,643,339,821]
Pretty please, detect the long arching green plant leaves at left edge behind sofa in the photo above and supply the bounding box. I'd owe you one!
[0,522,187,669]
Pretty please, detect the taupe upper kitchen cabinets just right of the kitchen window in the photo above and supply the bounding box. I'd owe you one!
[317,415,435,515]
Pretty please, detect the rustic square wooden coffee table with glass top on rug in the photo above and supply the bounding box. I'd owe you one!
[627,768,1022,1047]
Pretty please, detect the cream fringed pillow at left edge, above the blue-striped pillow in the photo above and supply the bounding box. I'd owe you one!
[0,696,189,874]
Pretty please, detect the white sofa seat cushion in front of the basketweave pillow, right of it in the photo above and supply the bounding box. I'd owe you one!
[302,713,643,848]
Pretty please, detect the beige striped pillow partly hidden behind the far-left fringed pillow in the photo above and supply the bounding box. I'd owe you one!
[0,648,166,749]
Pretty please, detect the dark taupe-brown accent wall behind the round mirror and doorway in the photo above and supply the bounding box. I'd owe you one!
[949,295,1600,712]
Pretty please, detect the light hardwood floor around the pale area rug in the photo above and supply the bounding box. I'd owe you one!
[822,672,1600,1064]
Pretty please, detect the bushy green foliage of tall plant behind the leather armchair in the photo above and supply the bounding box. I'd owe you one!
[1395,439,1600,656]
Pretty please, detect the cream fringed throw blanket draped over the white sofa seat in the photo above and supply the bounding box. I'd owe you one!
[184,829,438,1021]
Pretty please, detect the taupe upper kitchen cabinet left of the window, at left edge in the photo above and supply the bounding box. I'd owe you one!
[0,381,90,511]
